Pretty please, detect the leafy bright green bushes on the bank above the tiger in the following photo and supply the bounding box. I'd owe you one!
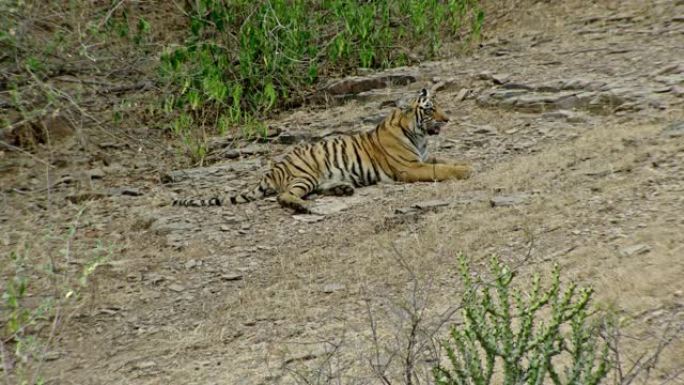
[159,0,484,152]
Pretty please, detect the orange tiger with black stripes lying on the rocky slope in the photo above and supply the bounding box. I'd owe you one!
[173,89,471,213]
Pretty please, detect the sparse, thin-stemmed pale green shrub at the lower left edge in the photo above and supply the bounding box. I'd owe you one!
[0,211,113,385]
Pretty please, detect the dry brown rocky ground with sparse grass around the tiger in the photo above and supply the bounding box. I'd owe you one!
[0,1,684,384]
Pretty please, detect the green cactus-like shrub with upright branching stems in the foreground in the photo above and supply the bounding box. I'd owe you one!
[433,256,610,385]
